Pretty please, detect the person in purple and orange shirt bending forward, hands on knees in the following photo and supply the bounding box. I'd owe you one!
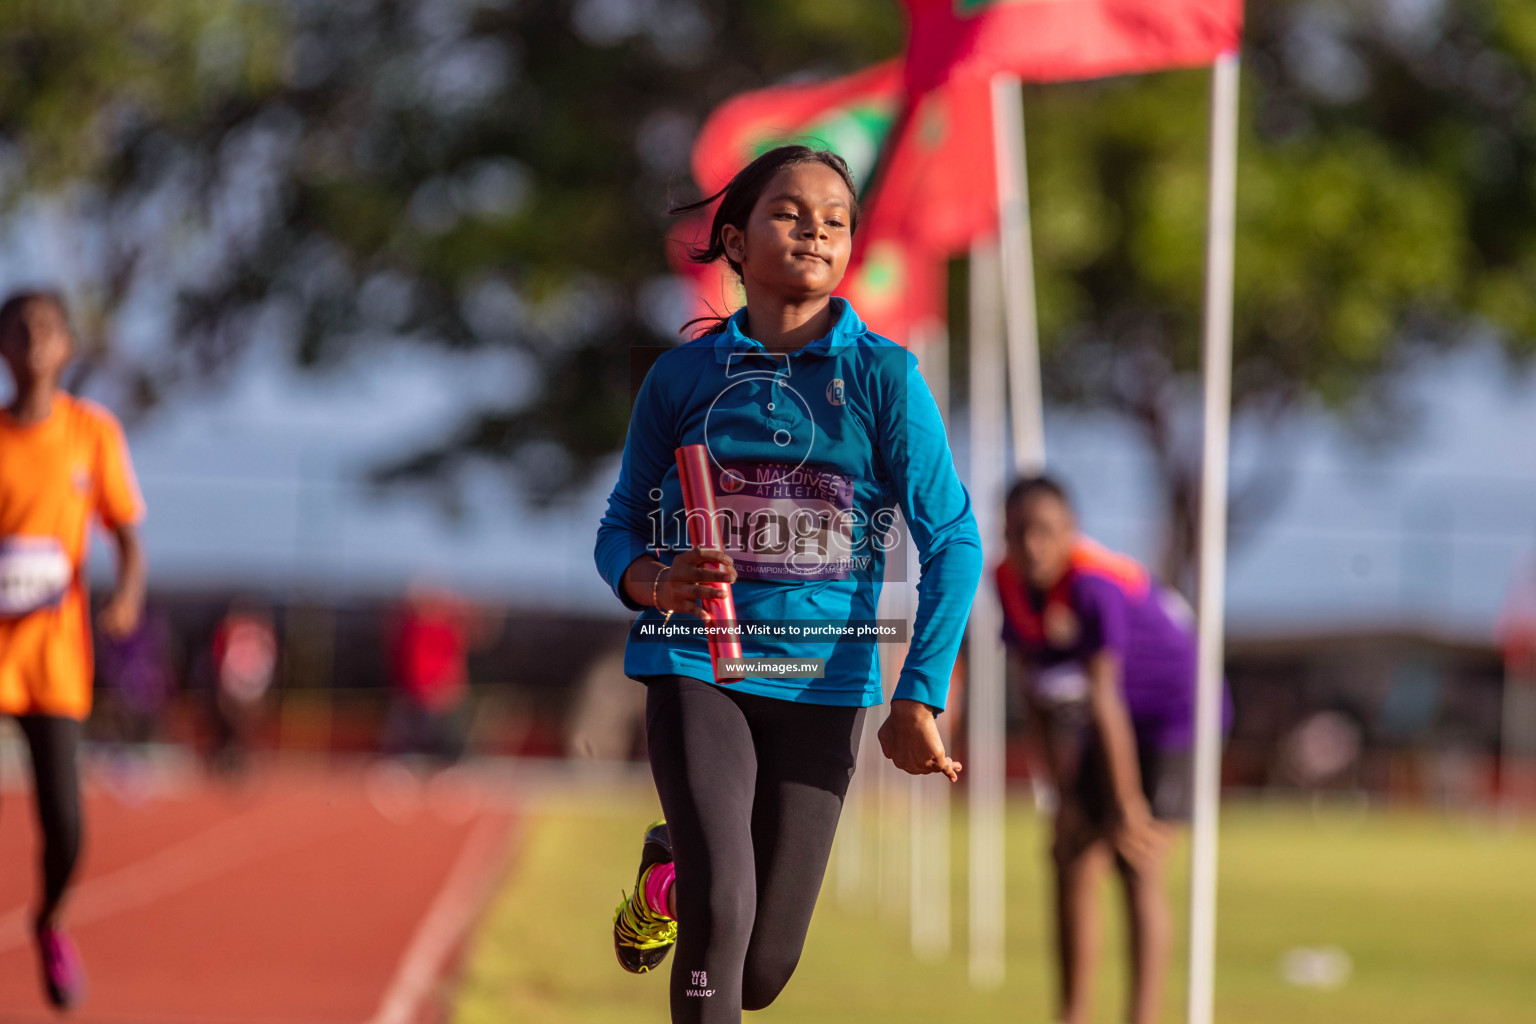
[997,477,1228,1024]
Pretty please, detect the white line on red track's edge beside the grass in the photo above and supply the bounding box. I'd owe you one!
[369,815,518,1024]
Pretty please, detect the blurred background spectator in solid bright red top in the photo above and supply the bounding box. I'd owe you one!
[382,583,476,765]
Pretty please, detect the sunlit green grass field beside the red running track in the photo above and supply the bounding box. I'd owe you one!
[455,791,1536,1024]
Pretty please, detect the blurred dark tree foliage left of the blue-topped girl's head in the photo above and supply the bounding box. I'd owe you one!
[0,0,902,497]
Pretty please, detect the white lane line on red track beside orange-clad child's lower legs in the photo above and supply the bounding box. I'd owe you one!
[0,797,339,952]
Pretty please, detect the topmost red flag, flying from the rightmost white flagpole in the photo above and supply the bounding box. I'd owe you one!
[906,0,1243,95]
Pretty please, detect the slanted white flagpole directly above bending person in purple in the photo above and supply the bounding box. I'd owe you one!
[992,74,1046,473]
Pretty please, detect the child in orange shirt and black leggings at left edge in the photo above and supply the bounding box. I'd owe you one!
[0,292,144,1007]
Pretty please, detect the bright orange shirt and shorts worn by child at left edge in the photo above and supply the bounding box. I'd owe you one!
[0,395,144,718]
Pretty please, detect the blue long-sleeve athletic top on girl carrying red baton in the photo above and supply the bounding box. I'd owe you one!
[596,298,982,711]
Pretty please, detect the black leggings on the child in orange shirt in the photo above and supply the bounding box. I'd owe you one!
[6,715,81,923]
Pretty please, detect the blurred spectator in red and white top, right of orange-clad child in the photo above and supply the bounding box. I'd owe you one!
[209,600,278,774]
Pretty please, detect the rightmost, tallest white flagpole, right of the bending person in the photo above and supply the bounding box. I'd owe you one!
[1187,52,1238,1024]
